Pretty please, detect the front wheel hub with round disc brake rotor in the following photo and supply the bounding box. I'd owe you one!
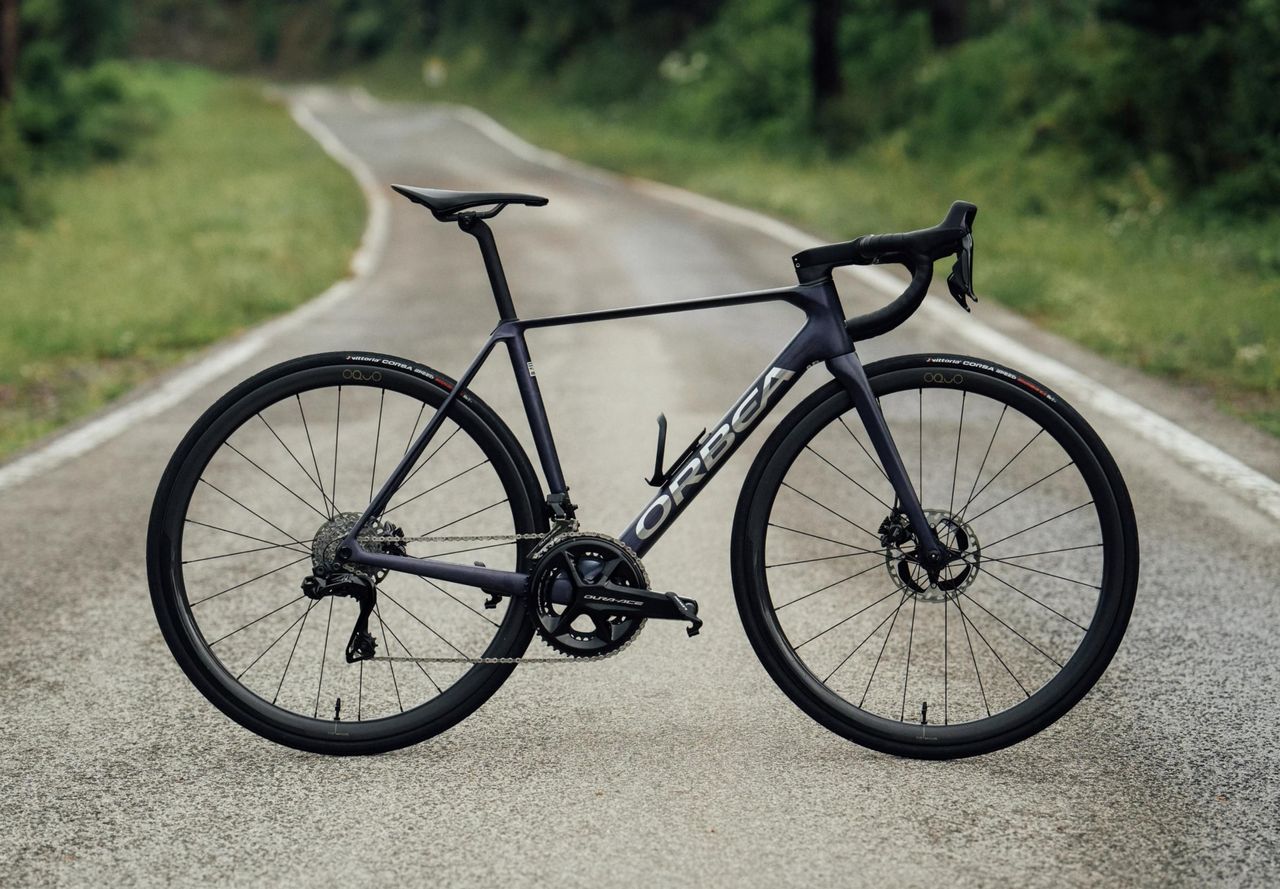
[882,509,982,602]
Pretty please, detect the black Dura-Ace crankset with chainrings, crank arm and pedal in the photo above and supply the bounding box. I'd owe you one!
[529,533,703,657]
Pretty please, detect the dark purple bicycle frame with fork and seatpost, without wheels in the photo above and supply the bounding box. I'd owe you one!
[339,217,943,595]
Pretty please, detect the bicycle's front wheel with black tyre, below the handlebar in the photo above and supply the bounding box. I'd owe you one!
[733,356,1138,759]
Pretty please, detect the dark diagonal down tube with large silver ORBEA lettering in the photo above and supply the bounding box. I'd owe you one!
[622,358,805,556]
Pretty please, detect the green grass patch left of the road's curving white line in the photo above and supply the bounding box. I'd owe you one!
[0,64,365,457]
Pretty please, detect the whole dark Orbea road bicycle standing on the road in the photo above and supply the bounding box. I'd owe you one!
[147,185,1138,759]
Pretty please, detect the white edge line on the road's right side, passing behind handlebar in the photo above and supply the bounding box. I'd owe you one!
[435,106,1280,519]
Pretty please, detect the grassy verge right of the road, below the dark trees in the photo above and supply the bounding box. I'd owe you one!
[353,56,1280,435]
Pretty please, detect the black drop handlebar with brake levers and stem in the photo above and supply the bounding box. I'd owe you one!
[791,201,978,342]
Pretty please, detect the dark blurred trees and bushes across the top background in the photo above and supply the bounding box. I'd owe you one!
[10,0,1280,214]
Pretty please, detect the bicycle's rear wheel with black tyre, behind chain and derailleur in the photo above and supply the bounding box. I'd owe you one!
[147,354,545,753]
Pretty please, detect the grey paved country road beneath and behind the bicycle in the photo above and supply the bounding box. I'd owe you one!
[0,92,1280,888]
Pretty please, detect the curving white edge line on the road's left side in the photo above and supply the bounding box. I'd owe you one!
[0,96,390,490]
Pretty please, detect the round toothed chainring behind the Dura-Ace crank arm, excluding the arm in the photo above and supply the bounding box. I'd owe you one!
[529,533,649,657]
